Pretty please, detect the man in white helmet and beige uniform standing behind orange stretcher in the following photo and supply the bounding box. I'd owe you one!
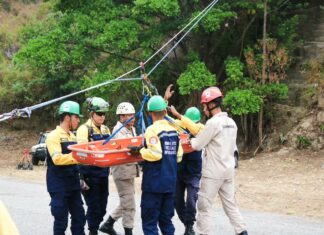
[99,102,139,235]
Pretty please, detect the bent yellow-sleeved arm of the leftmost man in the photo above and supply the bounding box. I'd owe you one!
[46,134,78,166]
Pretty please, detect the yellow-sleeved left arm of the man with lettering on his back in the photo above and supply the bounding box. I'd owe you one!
[140,128,162,162]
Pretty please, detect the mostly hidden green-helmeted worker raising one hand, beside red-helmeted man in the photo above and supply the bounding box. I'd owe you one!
[170,106,204,235]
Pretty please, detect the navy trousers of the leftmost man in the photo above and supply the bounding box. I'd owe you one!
[50,190,86,235]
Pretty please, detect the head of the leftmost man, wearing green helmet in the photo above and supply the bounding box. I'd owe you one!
[59,101,82,130]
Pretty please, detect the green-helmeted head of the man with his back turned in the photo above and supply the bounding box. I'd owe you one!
[147,95,167,121]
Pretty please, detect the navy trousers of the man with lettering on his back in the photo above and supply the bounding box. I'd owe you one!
[141,192,175,235]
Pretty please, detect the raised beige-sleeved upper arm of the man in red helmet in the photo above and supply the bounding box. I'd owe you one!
[190,122,219,151]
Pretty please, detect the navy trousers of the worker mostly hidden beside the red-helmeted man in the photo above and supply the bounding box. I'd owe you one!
[175,176,200,225]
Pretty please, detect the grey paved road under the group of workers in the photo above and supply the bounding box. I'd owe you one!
[0,177,324,235]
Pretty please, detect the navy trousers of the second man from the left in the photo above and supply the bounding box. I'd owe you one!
[82,176,109,230]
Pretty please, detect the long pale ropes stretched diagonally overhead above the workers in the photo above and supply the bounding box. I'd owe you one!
[0,0,219,122]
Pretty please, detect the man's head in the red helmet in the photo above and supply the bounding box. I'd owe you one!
[201,87,223,117]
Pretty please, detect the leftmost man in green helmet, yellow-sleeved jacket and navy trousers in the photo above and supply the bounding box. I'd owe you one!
[46,101,85,235]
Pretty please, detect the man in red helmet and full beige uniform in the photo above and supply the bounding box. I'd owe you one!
[191,87,248,235]
